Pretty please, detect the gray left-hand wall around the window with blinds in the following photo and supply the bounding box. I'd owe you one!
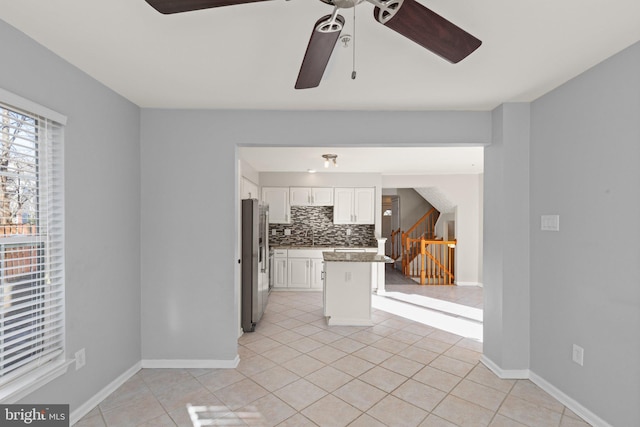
[0,21,140,411]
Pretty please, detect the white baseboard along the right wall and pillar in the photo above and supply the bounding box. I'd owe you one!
[480,354,612,427]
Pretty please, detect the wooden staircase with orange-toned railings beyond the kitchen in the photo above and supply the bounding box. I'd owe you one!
[391,208,456,285]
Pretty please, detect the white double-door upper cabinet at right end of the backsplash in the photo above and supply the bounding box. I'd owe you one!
[333,188,375,224]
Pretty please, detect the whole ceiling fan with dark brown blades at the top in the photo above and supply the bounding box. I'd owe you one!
[141,0,482,89]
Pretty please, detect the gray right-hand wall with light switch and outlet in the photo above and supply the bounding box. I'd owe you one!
[531,44,640,426]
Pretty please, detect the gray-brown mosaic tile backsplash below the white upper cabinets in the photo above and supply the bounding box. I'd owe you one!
[269,206,378,247]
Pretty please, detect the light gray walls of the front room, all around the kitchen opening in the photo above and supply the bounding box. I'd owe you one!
[11,9,640,426]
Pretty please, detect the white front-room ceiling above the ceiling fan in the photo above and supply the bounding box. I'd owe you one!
[0,0,640,110]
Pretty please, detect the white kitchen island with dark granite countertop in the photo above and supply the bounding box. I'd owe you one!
[322,252,393,326]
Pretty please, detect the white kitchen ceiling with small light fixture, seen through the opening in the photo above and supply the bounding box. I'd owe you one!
[239,147,484,175]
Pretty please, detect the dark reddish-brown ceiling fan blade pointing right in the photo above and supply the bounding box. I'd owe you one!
[373,0,482,64]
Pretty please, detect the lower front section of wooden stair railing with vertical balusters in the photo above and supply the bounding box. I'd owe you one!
[403,238,456,285]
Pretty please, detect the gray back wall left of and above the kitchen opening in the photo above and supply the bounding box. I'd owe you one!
[141,109,491,361]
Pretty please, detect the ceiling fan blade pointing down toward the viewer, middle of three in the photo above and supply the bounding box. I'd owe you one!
[295,13,344,89]
